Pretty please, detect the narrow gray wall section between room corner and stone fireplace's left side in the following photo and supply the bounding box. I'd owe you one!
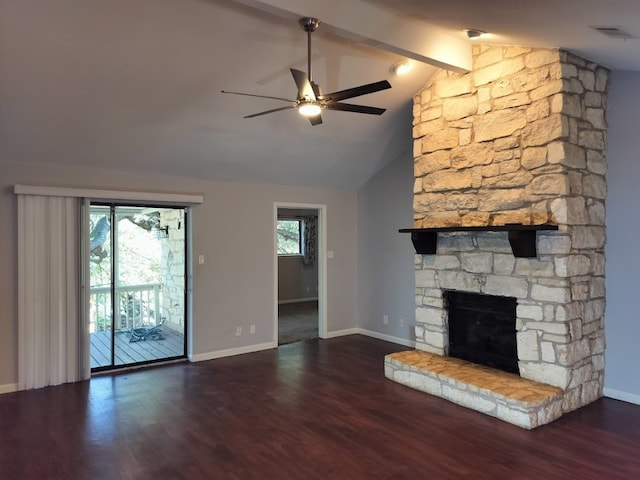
[358,150,415,340]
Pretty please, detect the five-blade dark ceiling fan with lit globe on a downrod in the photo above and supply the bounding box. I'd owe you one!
[222,17,391,125]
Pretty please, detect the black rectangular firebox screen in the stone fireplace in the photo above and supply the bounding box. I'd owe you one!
[444,290,519,373]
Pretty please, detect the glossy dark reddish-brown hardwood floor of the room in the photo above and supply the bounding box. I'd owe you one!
[0,335,640,480]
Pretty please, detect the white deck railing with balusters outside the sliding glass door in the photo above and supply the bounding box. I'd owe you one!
[89,283,162,333]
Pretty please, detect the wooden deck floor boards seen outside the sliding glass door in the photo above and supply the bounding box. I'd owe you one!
[91,326,184,368]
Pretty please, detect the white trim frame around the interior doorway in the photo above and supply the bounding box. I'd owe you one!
[271,202,327,348]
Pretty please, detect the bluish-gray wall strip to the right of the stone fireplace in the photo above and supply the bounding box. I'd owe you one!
[605,71,640,403]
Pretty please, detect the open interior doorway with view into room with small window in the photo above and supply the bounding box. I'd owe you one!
[275,204,326,345]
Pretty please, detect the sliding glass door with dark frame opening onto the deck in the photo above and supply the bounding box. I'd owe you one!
[88,203,187,372]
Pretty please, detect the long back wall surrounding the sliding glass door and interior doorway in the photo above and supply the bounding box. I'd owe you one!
[0,163,357,390]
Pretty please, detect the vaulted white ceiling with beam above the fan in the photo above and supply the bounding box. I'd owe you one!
[0,0,640,188]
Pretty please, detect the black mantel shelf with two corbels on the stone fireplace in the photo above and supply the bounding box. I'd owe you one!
[399,223,558,258]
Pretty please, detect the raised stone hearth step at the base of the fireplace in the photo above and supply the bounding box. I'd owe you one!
[384,350,563,429]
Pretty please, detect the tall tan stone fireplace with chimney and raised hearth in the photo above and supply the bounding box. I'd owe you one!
[385,45,608,428]
